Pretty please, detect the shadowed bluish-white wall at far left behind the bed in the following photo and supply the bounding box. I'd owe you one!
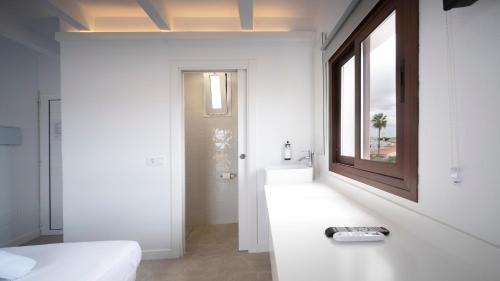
[0,36,40,246]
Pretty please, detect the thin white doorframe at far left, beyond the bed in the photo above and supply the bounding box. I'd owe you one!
[38,94,63,235]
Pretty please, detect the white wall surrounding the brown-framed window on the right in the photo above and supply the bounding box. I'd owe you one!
[316,0,500,246]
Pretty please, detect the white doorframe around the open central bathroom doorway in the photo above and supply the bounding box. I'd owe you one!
[170,60,257,257]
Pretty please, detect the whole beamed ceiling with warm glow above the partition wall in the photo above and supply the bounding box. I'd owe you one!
[0,0,340,55]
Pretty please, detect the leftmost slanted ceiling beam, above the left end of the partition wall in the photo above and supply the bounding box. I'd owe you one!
[42,0,90,31]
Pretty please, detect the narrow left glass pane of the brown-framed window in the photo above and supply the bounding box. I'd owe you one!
[340,57,355,157]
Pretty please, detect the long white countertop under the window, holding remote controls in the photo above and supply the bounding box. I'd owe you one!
[265,183,494,281]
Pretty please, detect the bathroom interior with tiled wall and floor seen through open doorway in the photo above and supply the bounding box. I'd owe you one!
[182,71,238,254]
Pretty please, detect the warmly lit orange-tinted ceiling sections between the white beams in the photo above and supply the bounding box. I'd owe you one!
[66,0,321,32]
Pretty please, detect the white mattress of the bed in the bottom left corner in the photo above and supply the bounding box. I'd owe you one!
[2,238,141,281]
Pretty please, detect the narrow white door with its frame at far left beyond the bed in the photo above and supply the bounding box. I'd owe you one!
[40,97,63,235]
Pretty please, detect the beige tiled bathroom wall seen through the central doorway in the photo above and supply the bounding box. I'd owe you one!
[183,72,238,225]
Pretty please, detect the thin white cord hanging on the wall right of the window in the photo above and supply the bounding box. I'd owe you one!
[445,12,462,183]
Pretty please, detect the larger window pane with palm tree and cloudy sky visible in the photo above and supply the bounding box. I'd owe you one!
[361,12,397,163]
